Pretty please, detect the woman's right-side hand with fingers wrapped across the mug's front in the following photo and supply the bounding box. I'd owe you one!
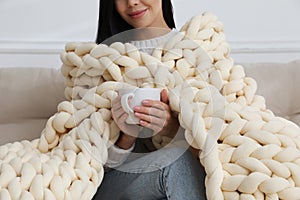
[134,90,179,137]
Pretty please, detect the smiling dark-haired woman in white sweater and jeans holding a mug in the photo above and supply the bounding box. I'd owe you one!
[93,0,206,200]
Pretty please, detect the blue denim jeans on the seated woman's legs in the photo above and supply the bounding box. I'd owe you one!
[93,147,206,200]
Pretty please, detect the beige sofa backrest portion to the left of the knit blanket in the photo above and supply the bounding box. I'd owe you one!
[0,68,65,144]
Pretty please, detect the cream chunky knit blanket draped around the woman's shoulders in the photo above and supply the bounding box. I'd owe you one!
[0,13,300,200]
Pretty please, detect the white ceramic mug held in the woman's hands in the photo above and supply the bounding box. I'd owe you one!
[119,88,161,124]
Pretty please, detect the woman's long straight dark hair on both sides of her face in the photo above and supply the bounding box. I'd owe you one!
[96,0,176,44]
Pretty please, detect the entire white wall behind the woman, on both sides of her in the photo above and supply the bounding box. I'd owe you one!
[0,0,300,68]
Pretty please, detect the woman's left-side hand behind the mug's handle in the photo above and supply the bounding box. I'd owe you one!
[111,96,139,149]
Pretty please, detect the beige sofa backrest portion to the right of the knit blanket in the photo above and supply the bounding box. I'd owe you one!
[243,60,300,125]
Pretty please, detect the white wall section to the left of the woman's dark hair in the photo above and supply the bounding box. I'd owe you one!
[0,0,98,68]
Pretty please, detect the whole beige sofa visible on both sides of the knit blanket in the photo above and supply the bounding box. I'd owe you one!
[0,60,300,145]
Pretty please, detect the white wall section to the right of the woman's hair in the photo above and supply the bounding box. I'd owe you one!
[174,0,300,62]
